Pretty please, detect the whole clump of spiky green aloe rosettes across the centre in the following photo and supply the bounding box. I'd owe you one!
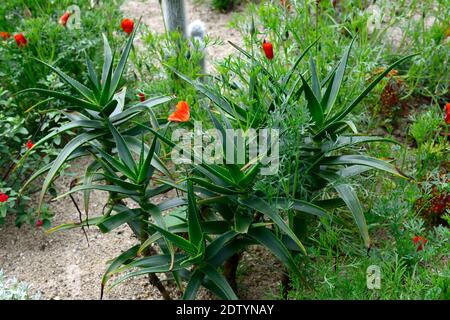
[16,20,418,299]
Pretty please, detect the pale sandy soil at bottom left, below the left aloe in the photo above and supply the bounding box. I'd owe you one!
[0,160,172,299]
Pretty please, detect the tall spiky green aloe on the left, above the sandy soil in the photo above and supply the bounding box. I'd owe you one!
[19,23,173,298]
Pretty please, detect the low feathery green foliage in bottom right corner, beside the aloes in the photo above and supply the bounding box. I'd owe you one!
[290,183,449,300]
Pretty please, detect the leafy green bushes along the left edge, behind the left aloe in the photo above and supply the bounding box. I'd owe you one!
[0,0,125,226]
